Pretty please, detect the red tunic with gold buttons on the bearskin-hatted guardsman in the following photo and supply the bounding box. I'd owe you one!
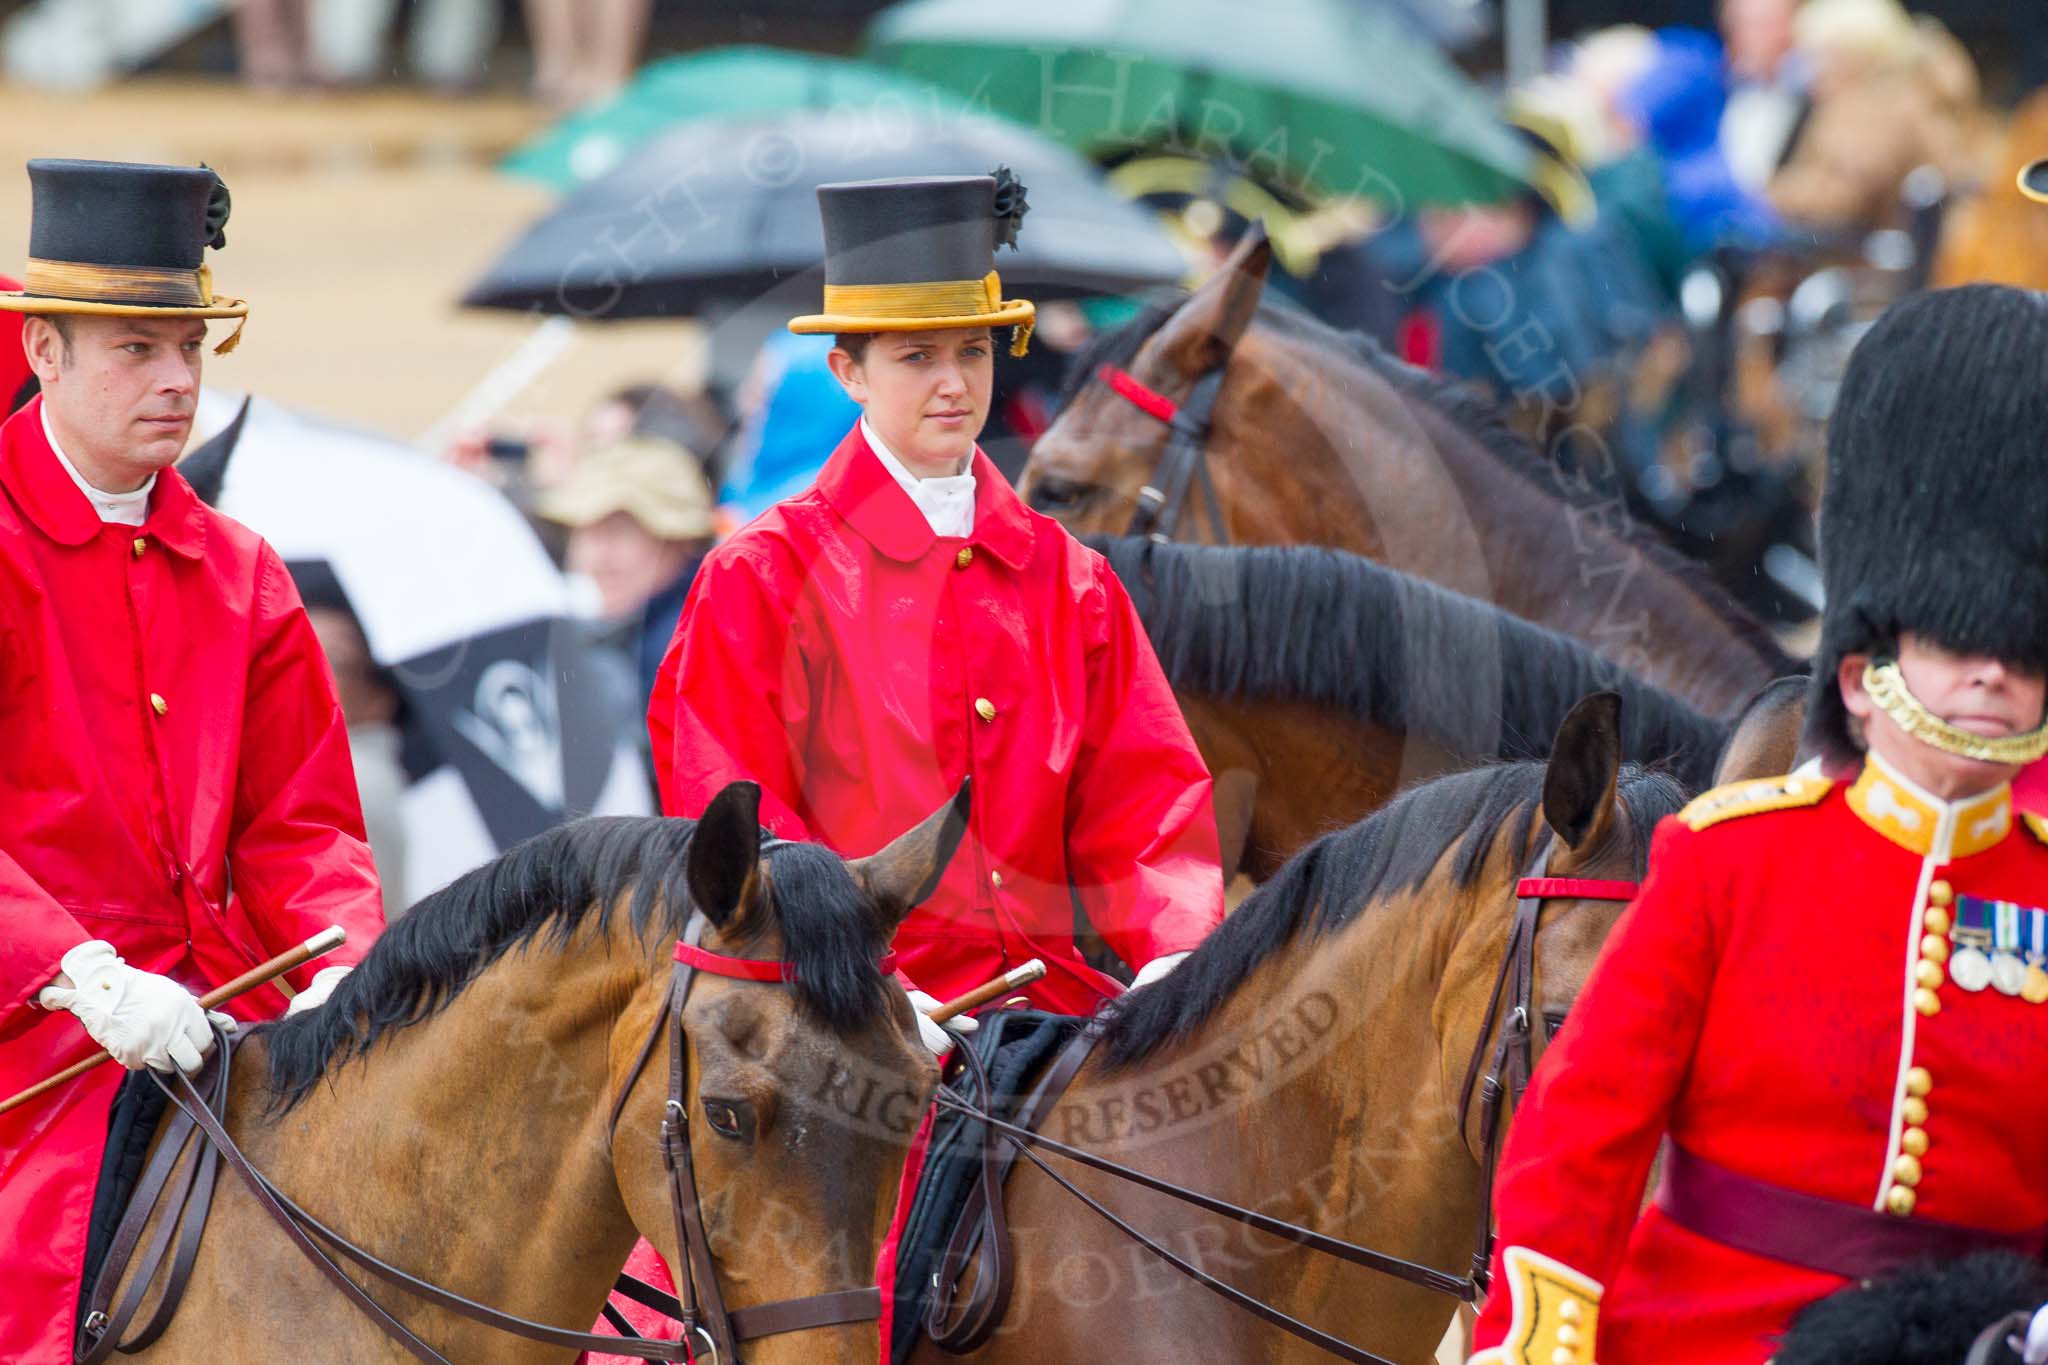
[1477,759,2048,1365]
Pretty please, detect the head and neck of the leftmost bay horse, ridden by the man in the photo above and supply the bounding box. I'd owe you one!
[172,782,969,1365]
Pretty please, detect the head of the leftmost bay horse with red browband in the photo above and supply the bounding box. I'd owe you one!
[612,782,969,1363]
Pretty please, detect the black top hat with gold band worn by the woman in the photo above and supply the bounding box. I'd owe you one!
[788,168,1036,356]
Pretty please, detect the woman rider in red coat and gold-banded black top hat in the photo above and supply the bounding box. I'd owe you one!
[649,172,1223,1048]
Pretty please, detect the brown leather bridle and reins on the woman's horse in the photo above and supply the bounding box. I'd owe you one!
[928,837,1636,1365]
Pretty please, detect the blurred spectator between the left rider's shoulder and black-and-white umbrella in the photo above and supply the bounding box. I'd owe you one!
[291,563,410,923]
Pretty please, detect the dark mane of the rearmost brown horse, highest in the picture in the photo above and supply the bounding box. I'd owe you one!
[1059,291,1800,677]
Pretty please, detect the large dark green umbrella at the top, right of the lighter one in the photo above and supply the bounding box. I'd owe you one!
[868,0,1536,211]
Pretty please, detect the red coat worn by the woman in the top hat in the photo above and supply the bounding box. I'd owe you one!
[647,426,1223,1013]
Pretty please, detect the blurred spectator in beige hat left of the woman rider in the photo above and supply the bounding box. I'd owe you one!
[535,436,713,714]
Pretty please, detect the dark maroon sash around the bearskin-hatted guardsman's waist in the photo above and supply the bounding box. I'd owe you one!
[1657,1142,2048,1279]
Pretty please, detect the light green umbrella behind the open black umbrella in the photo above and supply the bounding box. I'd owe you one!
[502,47,961,190]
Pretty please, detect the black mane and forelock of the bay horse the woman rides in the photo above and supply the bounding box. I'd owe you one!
[1102,763,1686,1066]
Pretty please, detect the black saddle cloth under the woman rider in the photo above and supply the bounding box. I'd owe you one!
[889,1009,1085,1365]
